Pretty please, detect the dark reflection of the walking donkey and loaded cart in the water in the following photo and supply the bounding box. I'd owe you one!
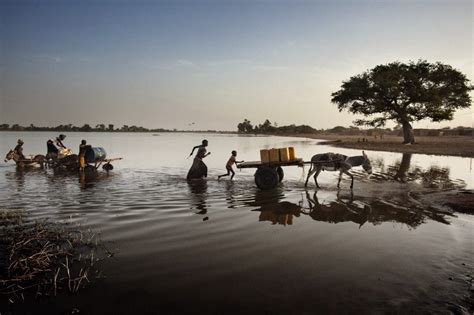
[252,191,449,228]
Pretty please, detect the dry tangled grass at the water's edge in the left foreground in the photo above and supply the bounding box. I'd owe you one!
[0,210,111,303]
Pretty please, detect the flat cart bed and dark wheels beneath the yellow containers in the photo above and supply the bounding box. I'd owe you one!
[237,159,304,189]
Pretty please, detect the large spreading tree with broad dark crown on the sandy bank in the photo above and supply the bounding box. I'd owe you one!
[331,60,473,143]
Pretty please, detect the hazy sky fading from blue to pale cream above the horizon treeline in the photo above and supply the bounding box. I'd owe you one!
[0,0,474,130]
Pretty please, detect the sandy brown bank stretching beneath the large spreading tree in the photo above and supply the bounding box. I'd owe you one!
[305,135,474,157]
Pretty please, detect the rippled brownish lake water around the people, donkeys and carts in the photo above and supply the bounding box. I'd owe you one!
[0,133,474,314]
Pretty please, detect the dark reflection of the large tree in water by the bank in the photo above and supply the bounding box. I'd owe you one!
[383,153,466,189]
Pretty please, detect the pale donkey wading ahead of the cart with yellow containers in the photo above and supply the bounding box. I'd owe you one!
[304,151,372,189]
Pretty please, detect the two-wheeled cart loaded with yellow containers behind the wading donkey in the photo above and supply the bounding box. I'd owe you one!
[237,147,304,189]
